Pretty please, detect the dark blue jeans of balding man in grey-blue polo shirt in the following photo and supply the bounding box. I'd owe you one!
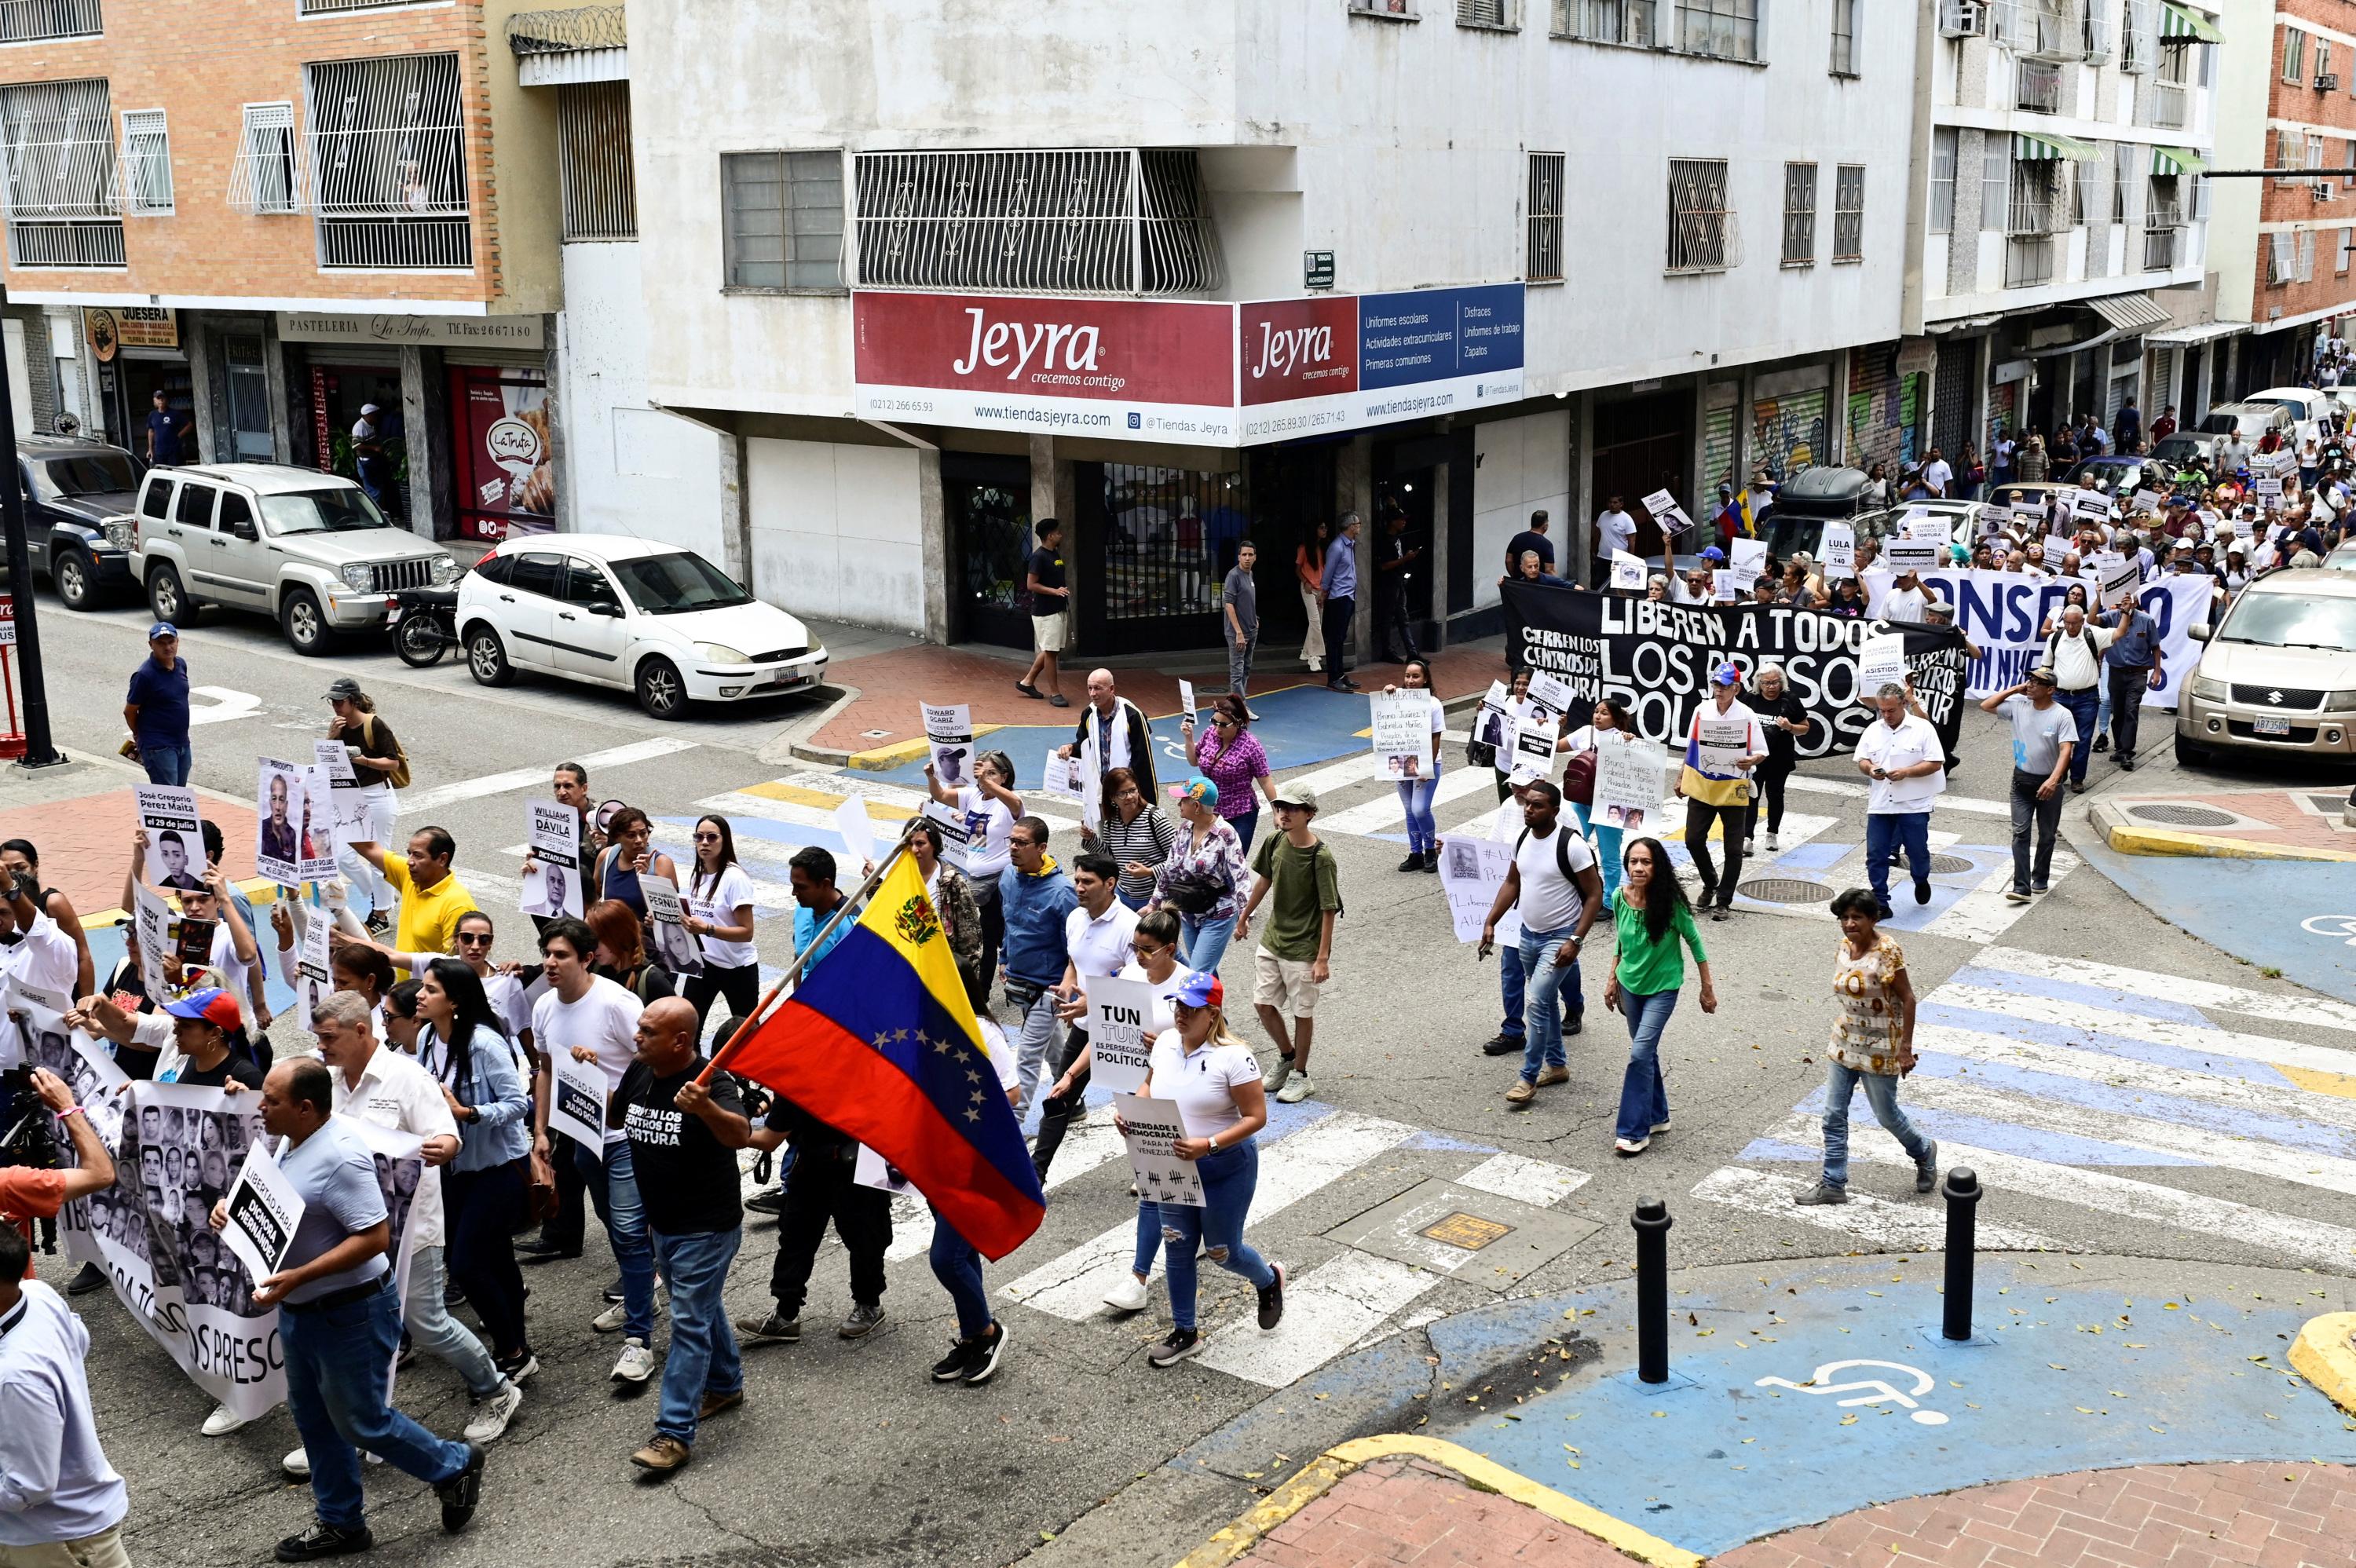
[278,1274,466,1530]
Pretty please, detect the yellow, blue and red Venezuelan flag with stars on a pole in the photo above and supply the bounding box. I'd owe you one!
[716,854,1046,1259]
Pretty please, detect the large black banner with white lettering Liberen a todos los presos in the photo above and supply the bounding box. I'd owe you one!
[1503,582,1967,763]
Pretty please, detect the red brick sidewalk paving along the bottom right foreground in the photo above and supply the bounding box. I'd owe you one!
[1242,1457,2356,1568]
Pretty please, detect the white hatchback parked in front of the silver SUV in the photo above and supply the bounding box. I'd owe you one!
[457,535,827,718]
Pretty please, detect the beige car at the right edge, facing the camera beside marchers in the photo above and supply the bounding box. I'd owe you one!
[2177,568,2356,763]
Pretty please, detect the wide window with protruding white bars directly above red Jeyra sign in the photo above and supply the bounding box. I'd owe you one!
[858,146,1220,297]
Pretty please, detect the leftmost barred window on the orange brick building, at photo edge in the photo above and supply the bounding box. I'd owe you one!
[0,80,123,269]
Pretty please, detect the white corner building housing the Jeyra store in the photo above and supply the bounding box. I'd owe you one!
[631,0,1932,652]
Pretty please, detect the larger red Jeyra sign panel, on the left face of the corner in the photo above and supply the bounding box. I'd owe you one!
[851,294,1235,408]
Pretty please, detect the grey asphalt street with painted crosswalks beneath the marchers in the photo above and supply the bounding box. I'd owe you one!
[0,596,2356,1568]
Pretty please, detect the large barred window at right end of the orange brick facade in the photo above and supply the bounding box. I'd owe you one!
[304,54,474,269]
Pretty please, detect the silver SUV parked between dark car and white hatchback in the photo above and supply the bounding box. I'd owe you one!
[137,464,462,655]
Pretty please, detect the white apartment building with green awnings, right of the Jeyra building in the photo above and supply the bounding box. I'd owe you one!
[1908,0,2226,450]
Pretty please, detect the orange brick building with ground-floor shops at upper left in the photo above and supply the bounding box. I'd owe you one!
[0,0,561,537]
